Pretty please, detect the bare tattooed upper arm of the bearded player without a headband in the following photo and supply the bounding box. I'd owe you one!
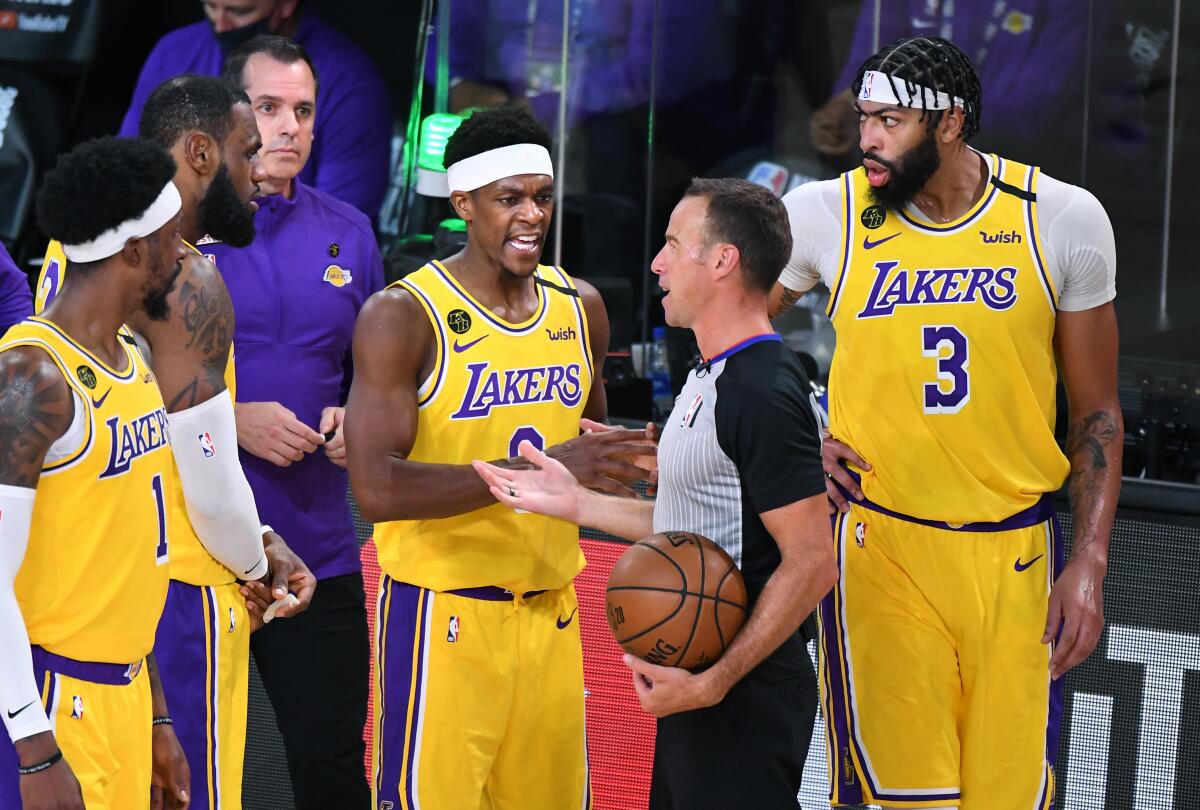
[130,254,233,413]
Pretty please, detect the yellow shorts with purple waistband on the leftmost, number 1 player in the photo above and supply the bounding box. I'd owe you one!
[0,648,154,810]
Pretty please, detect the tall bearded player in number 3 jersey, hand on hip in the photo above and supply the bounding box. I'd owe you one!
[775,37,1122,810]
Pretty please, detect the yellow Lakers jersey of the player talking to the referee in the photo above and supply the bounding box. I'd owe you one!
[374,262,594,592]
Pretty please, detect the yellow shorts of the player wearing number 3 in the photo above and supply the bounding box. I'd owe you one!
[820,500,1062,810]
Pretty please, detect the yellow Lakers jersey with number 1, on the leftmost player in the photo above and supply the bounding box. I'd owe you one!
[0,318,175,664]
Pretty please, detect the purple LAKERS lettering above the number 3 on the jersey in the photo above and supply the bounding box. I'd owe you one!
[857,262,1016,318]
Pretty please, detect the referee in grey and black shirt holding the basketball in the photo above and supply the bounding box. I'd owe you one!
[475,180,836,810]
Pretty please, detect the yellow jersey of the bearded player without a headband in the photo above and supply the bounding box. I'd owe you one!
[34,241,236,586]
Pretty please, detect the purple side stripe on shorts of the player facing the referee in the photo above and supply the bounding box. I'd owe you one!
[376,576,425,808]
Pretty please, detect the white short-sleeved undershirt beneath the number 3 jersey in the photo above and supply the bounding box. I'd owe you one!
[779,150,1117,312]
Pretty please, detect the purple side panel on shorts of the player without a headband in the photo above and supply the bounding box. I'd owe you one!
[154,580,216,810]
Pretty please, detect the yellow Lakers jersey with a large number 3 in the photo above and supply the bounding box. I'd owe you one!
[829,156,1069,523]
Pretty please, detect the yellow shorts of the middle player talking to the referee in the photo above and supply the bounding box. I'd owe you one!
[372,575,592,810]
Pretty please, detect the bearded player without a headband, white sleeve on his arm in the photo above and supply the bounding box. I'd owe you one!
[38,76,314,810]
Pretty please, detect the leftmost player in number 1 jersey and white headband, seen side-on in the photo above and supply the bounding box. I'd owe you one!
[0,138,187,810]
